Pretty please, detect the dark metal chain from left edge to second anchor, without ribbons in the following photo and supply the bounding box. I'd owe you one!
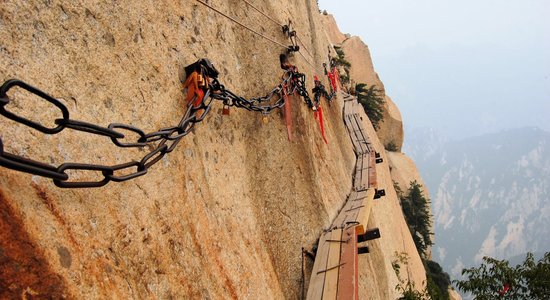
[0,60,316,188]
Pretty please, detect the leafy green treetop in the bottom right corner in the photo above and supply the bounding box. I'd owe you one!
[454,252,550,300]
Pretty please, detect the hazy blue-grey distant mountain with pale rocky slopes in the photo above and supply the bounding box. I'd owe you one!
[405,127,550,278]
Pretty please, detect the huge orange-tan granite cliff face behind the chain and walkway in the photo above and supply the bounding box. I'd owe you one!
[0,0,425,299]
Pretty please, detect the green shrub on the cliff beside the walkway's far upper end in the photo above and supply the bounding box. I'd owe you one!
[355,83,386,129]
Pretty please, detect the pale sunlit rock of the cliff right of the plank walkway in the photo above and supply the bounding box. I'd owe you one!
[321,14,431,299]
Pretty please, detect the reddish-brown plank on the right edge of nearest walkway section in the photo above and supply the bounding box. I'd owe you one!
[337,226,359,300]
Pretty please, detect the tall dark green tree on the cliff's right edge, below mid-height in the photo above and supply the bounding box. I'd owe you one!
[401,180,433,258]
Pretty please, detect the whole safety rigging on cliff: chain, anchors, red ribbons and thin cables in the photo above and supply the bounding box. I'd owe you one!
[0,0,331,188]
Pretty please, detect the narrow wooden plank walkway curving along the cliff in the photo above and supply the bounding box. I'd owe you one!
[307,92,384,300]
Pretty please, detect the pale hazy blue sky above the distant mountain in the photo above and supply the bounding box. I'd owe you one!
[319,0,550,138]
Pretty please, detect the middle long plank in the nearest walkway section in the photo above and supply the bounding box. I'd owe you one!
[323,229,342,300]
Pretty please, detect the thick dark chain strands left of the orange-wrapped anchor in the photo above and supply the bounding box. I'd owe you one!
[0,79,212,188]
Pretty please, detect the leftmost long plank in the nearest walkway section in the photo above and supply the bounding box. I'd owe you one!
[306,232,332,300]
